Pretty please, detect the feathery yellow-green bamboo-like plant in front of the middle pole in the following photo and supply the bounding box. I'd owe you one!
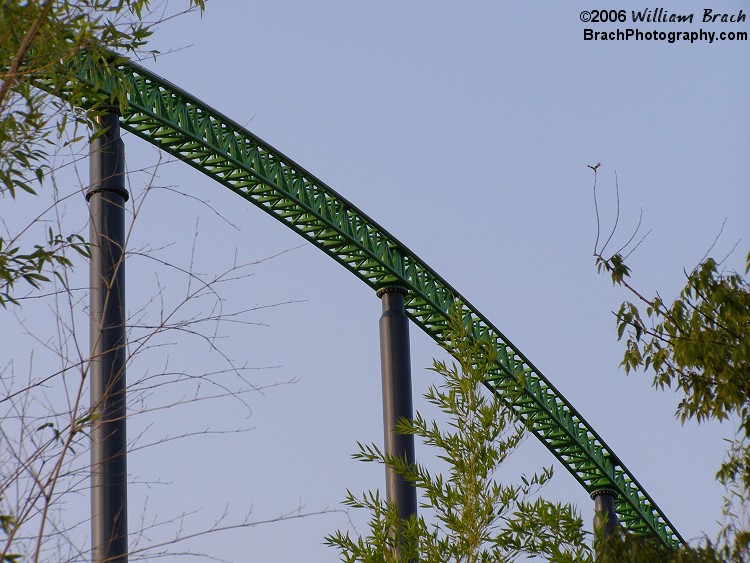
[326,309,591,563]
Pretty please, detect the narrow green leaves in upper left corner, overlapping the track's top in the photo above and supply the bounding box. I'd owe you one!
[0,0,204,305]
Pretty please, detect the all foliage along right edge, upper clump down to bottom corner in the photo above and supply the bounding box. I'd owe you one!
[596,253,750,561]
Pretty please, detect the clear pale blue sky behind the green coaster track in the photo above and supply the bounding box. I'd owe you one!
[5,0,750,563]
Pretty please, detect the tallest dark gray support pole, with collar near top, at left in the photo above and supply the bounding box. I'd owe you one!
[86,113,128,563]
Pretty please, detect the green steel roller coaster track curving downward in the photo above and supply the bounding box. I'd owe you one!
[64,51,684,547]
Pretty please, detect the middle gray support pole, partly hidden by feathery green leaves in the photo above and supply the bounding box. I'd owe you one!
[378,287,417,519]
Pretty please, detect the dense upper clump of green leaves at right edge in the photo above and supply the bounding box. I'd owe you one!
[617,258,750,432]
